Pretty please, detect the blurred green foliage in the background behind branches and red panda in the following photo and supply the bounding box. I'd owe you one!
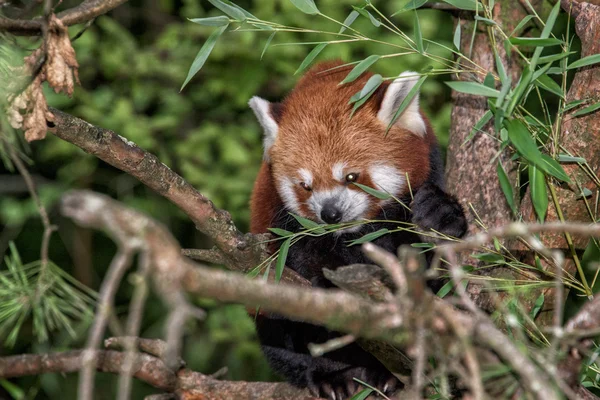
[0,0,453,399]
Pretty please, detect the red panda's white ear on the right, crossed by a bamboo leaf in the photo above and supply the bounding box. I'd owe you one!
[377,71,427,136]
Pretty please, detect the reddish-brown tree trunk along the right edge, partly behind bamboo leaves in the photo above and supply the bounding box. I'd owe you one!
[520,0,600,325]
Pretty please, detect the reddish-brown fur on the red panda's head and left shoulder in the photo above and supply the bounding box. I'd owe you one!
[250,62,436,233]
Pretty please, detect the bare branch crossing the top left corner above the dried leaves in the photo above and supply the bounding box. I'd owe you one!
[0,0,127,35]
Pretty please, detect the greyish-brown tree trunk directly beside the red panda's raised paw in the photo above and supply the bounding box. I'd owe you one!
[446,0,541,311]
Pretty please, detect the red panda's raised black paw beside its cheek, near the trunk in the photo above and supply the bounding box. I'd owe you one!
[411,183,468,238]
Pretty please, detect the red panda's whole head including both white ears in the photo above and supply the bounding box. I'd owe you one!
[250,59,430,228]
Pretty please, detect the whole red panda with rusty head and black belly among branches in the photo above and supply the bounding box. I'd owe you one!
[249,62,467,400]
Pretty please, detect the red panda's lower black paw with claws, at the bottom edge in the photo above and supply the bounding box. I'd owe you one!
[309,367,402,400]
